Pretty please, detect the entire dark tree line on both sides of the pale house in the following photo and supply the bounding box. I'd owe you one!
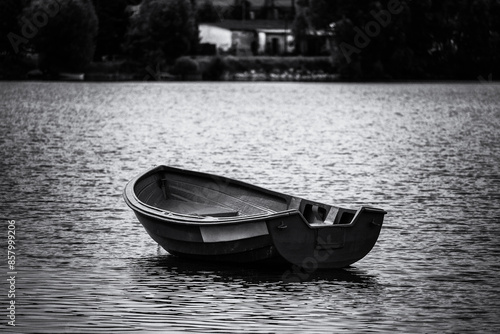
[0,0,500,80]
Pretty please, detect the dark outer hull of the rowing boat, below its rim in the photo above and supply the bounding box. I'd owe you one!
[131,208,384,269]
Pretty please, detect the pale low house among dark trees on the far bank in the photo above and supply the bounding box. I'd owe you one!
[199,20,295,56]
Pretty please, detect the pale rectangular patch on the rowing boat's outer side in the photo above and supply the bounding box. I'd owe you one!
[200,221,269,242]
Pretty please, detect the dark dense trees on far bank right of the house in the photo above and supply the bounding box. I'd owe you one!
[297,0,500,79]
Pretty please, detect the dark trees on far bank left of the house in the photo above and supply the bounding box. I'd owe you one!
[0,0,199,77]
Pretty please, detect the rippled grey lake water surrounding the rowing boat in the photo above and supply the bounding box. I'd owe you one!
[0,82,500,333]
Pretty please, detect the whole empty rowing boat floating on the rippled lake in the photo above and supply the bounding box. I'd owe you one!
[124,166,386,269]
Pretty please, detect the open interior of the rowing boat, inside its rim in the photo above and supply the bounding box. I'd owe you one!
[134,168,356,225]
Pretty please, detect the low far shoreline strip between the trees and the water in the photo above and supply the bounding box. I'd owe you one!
[0,55,498,84]
